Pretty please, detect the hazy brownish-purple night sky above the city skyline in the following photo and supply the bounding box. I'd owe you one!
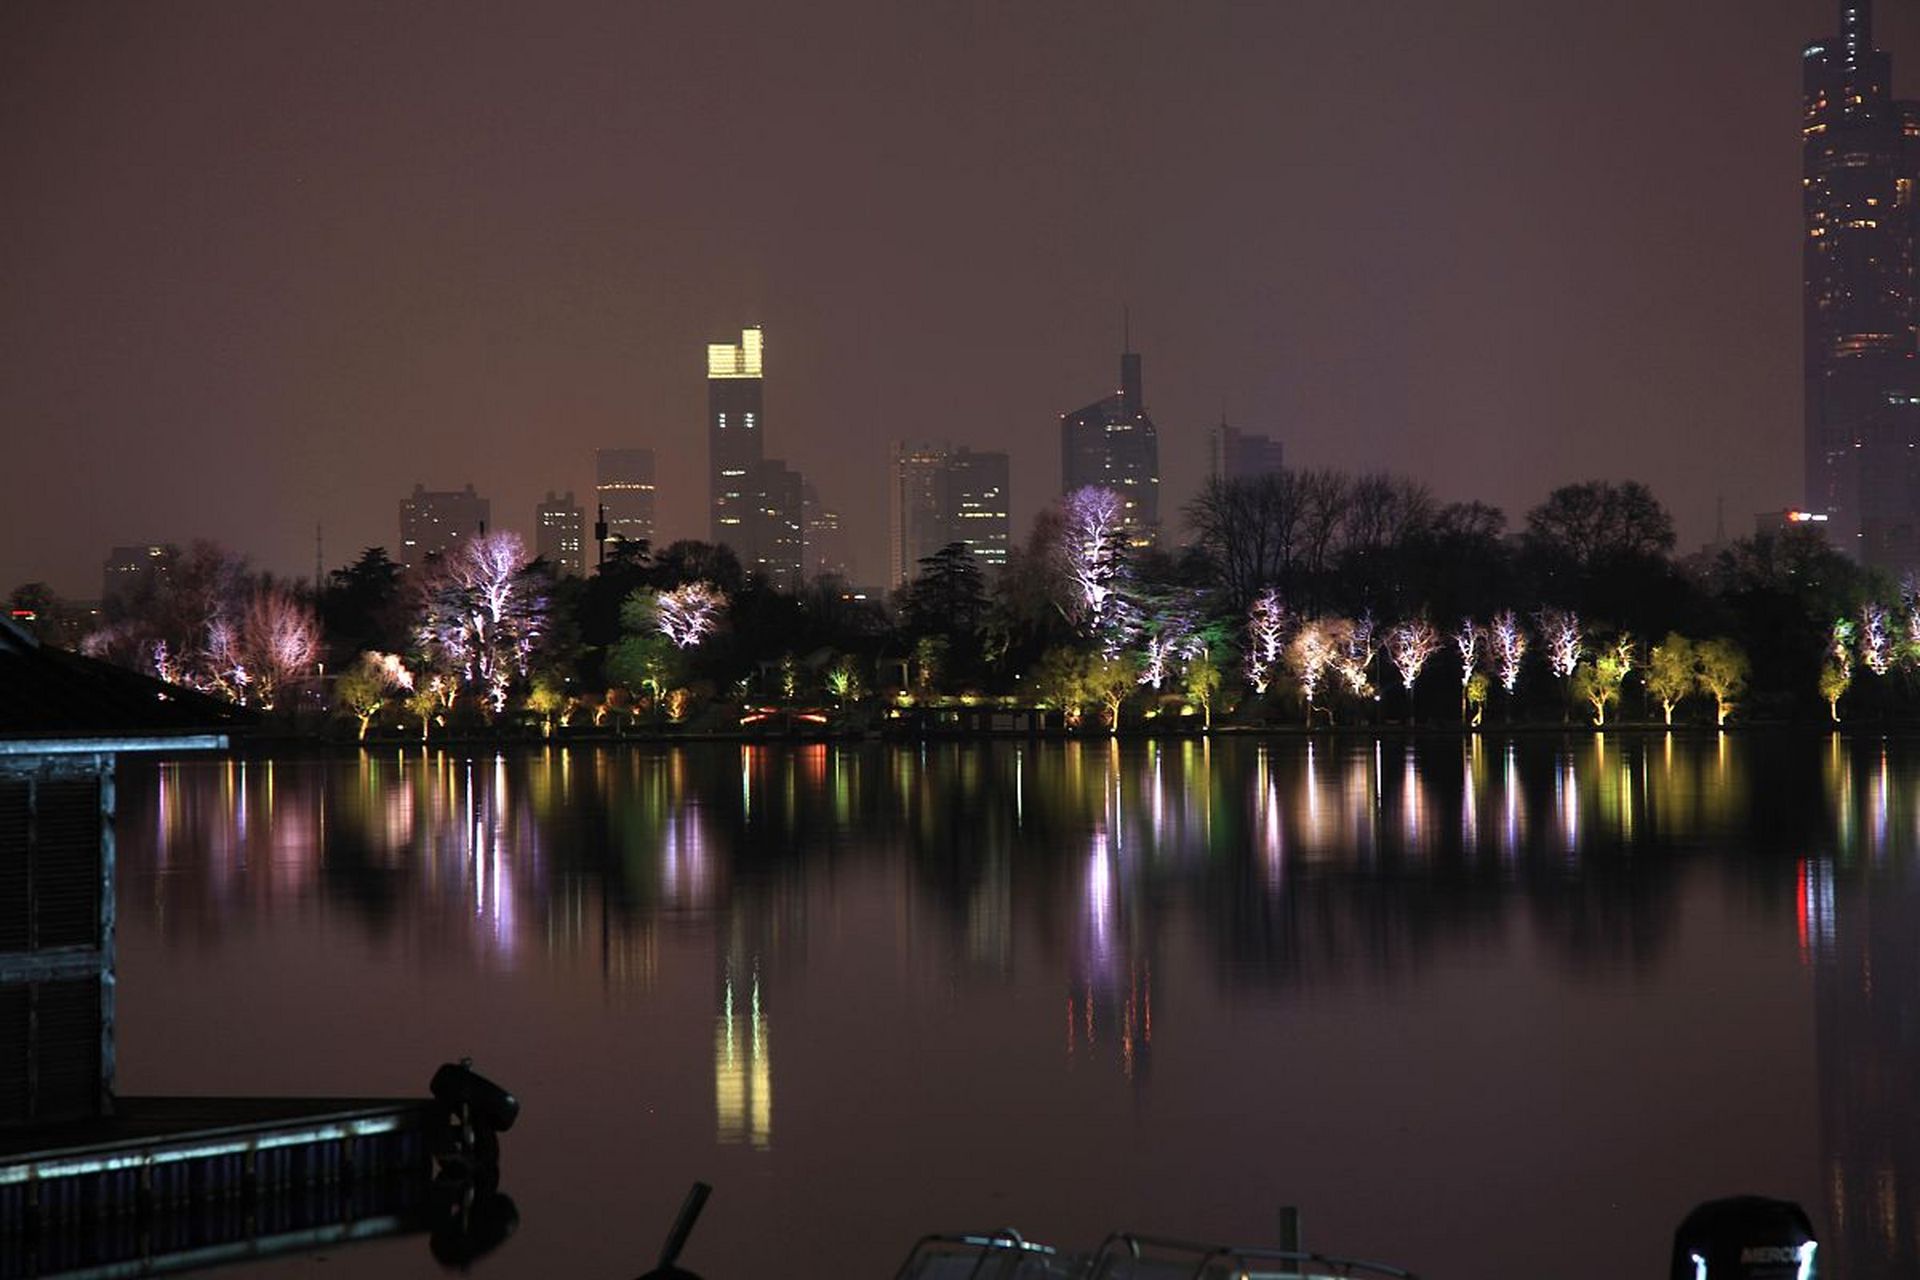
[0,0,1920,597]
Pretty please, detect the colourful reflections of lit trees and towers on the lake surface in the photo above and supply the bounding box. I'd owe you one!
[108,733,1920,1276]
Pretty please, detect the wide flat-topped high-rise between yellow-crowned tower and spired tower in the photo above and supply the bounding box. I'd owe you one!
[887,441,1012,587]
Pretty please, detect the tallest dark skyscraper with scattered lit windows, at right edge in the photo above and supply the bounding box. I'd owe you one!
[1801,0,1920,570]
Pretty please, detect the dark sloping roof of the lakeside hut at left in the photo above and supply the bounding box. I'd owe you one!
[0,618,250,739]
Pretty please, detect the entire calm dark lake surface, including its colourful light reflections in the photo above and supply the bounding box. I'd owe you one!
[108,735,1920,1280]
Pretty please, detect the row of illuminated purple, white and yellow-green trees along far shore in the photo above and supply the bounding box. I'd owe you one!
[15,470,1920,731]
